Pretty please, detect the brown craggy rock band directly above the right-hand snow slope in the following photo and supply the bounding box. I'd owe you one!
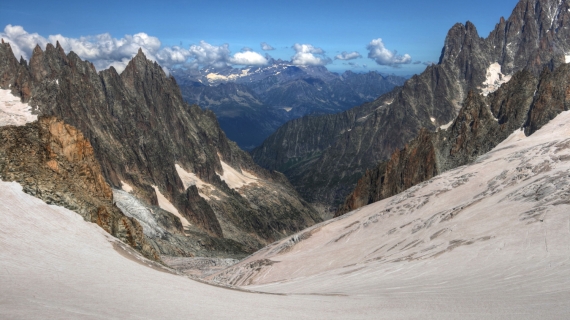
[336,64,570,216]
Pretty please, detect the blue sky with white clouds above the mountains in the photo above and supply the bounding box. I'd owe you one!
[0,0,518,75]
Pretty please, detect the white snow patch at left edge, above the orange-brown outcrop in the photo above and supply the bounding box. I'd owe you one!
[0,89,38,127]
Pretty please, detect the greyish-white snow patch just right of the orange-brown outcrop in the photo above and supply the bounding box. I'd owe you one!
[113,189,164,238]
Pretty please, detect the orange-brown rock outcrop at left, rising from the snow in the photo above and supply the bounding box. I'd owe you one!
[0,117,160,260]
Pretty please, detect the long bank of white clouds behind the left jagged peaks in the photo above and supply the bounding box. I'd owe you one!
[0,25,267,73]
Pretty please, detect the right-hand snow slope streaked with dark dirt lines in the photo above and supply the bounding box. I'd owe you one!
[213,112,570,319]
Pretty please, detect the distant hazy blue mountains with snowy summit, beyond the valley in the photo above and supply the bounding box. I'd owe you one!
[172,65,405,150]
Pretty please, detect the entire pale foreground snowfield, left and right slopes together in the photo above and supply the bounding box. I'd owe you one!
[0,112,570,319]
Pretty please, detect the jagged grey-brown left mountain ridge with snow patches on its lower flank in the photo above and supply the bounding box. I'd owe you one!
[0,43,320,255]
